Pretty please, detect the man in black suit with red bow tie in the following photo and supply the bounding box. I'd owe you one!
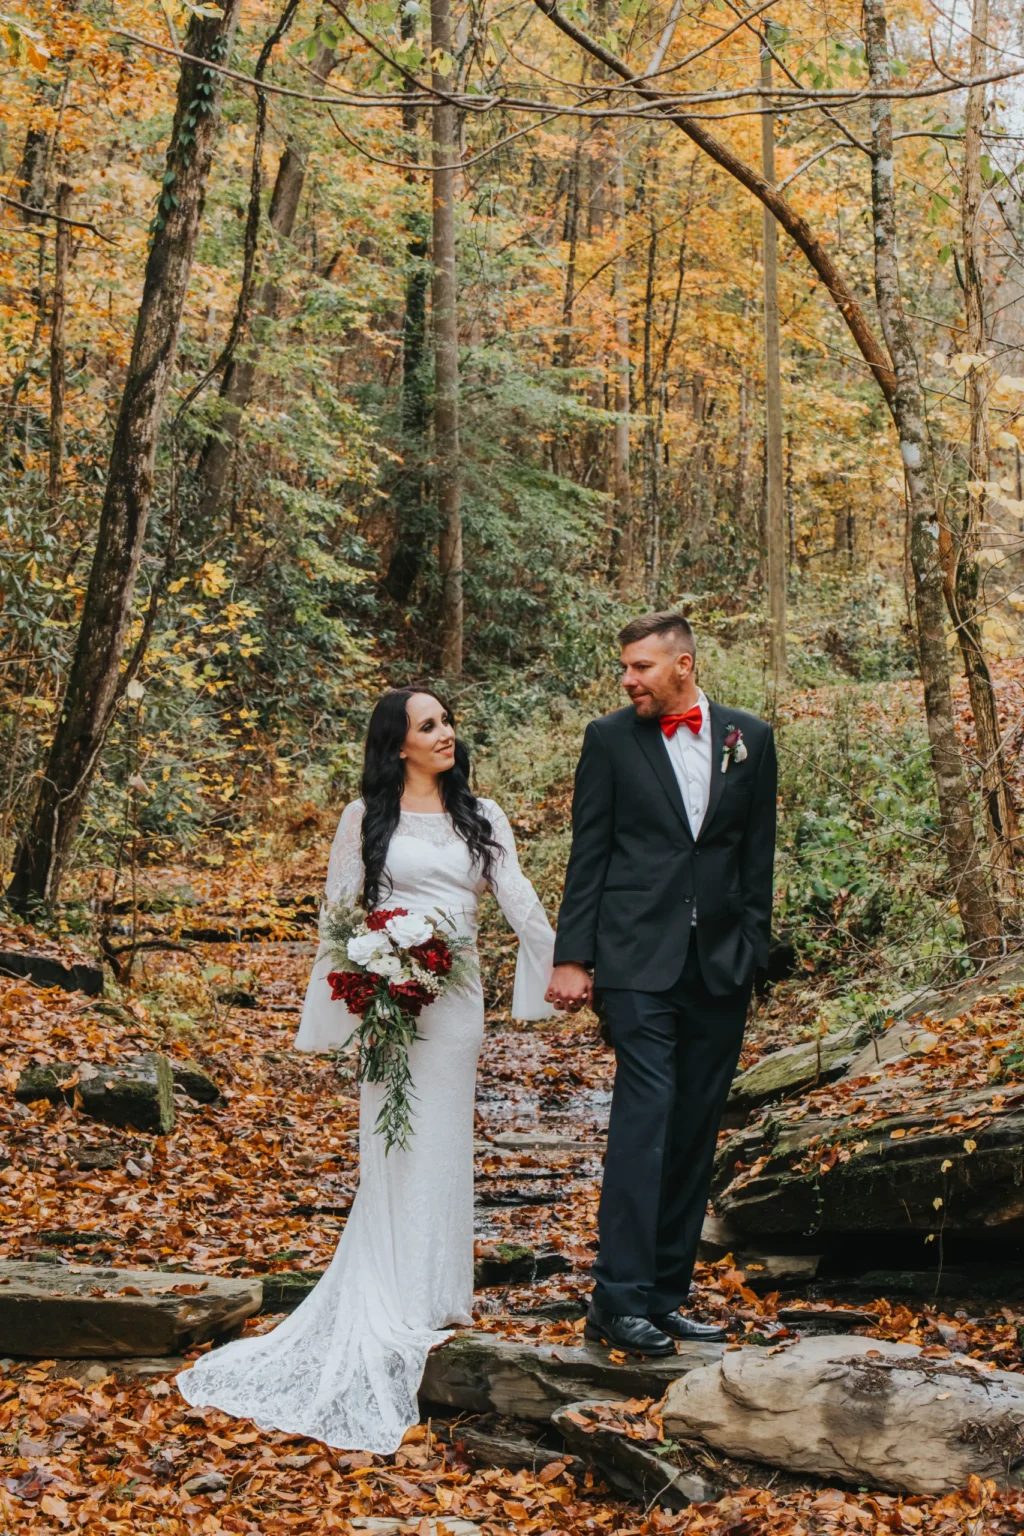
[548,613,777,1355]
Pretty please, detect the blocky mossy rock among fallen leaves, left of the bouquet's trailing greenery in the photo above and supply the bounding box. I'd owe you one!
[14,1051,173,1135]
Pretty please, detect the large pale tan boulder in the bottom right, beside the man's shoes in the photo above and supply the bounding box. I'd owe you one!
[662,1335,1024,1495]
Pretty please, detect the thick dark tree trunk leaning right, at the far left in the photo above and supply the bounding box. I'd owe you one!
[8,0,239,911]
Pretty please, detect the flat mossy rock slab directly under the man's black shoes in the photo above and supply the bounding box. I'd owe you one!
[419,1333,725,1424]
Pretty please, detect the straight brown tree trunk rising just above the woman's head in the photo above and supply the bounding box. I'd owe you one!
[430,0,462,677]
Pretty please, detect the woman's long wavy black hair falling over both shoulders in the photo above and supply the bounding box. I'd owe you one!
[361,688,502,911]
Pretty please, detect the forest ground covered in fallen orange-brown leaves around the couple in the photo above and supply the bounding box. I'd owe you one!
[0,674,1024,1536]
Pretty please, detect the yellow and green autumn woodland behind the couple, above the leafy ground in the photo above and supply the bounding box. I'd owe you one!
[0,0,1024,986]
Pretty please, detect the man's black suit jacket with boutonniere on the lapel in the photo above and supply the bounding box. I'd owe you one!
[554,703,777,995]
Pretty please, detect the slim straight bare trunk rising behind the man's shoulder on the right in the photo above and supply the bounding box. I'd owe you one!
[761,52,786,688]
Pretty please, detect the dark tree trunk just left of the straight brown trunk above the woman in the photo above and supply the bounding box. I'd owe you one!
[384,8,430,607]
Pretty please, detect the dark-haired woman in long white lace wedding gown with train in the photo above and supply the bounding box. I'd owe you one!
[177,688,554,1455]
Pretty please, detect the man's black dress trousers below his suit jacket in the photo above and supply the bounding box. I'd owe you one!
[594,935,751,1316]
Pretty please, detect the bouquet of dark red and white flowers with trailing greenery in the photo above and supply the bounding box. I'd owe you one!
[324,903,473,1152]
